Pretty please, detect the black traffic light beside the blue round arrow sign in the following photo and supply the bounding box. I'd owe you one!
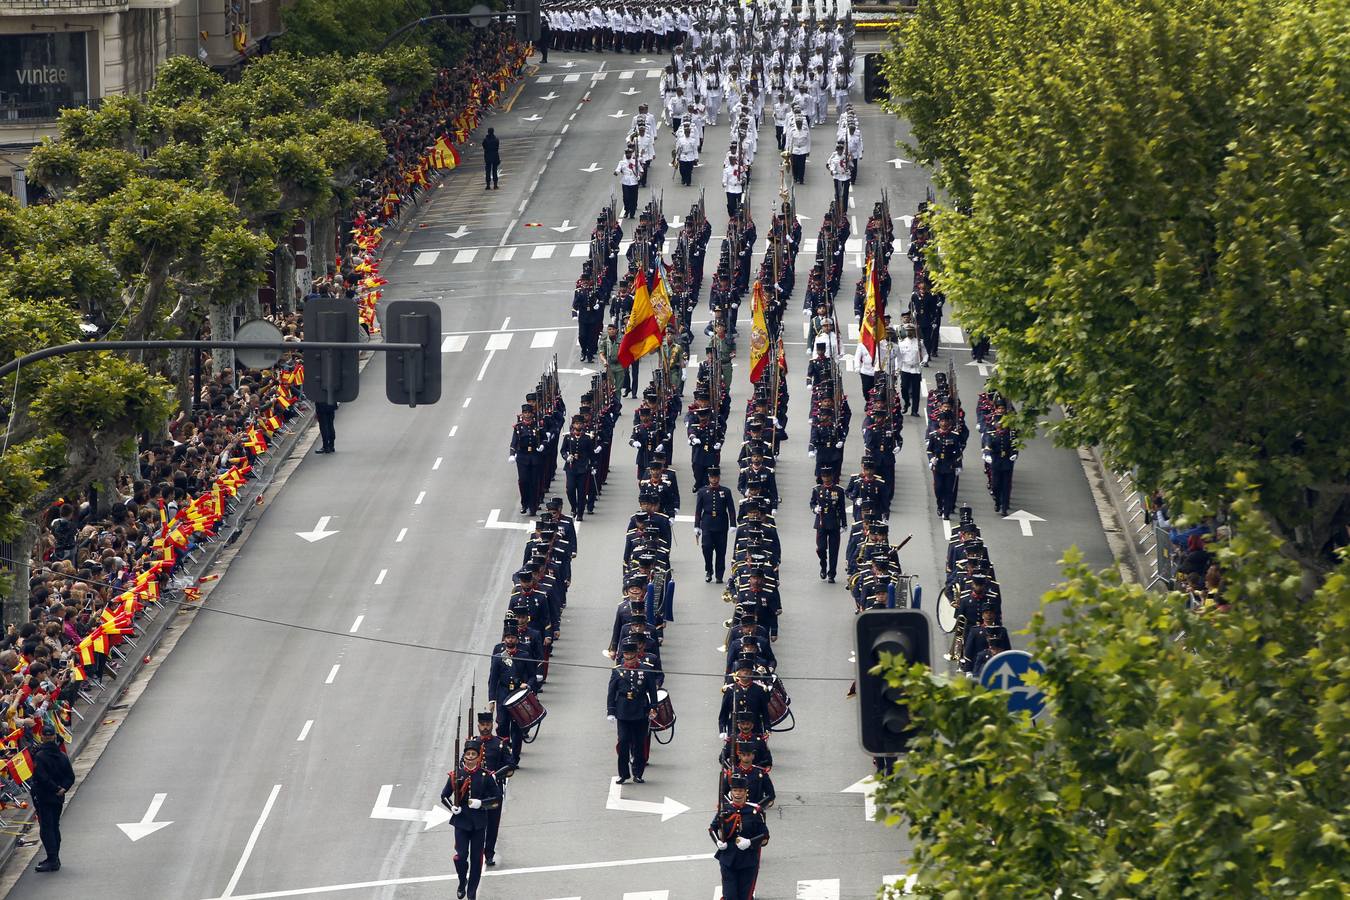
[855,610,933,756]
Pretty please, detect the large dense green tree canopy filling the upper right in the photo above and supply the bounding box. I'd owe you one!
[888,0,1350,572]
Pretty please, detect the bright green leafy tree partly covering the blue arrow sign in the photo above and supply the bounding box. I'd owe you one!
[878,478,1350,899]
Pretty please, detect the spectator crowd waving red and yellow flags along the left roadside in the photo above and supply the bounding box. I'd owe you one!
[0,28,531,835]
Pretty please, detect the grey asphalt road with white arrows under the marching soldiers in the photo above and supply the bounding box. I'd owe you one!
[12,54,1111,900]
